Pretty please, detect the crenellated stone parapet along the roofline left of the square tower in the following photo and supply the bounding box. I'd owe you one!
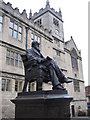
[0,1,51,37]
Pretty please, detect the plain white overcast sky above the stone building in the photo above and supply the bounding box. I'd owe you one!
[3,0,88,85]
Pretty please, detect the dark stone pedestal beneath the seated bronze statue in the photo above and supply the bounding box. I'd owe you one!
[11,90,72,120]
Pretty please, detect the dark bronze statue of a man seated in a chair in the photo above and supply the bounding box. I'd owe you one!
[21,41,72,92]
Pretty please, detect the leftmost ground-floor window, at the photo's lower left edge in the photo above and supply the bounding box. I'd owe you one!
[2,79,11,91]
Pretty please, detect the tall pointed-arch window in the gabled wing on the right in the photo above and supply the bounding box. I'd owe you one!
[71,49,78,70]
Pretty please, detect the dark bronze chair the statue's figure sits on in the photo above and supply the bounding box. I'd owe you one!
[21,55,50,92]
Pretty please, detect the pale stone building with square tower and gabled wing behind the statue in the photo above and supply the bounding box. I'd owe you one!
[0,0,87,118]
